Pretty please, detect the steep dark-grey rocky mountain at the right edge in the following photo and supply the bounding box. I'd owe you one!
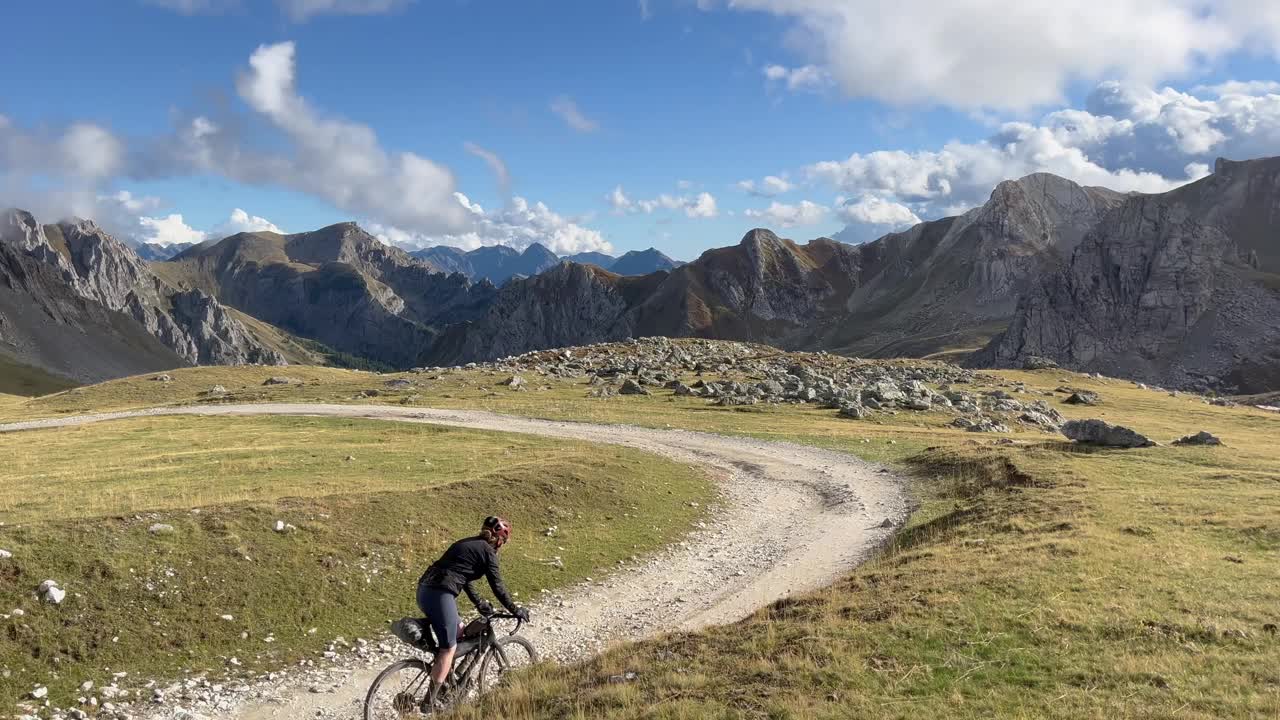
[968,160,1280,392]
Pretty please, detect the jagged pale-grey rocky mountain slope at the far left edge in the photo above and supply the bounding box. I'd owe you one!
[0,210,283,380]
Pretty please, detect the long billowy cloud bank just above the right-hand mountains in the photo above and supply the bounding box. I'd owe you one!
[801,81,1280,226]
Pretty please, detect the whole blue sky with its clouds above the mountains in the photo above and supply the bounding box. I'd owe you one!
[0,0,1280,259]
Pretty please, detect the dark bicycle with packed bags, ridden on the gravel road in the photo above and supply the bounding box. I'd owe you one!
[365,612,538,720]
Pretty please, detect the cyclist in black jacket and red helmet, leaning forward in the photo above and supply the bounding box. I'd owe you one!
[417,515,529,711]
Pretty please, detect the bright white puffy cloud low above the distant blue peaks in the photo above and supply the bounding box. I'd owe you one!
[370,192,613,255]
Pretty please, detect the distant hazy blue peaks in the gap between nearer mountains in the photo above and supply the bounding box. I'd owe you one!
[412,242,681,286]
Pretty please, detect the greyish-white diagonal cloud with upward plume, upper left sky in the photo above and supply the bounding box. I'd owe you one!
[183,42,467,233]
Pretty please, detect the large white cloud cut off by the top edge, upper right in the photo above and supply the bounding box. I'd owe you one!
[708,0,1280,109]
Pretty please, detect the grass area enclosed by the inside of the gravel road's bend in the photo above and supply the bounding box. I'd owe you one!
[0,418,713,705]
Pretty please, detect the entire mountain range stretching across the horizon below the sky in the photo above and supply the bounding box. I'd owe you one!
[0,159,1280,392]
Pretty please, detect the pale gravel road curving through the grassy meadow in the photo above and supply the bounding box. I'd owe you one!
[0,404,909,720]
